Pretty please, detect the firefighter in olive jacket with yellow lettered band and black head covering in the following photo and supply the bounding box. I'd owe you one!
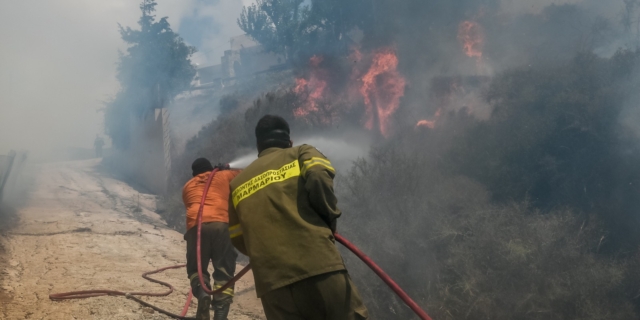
[229,115,368,320]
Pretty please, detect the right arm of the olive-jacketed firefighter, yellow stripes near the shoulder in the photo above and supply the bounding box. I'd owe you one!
[300,146,342,232]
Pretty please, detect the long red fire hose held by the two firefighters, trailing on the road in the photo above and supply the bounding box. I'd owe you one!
[49,168,432,320]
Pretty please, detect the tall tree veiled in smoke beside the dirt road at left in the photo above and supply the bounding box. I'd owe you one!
[105,0,195,149]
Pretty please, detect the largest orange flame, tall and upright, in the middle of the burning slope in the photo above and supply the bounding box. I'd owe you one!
[360,48,406,136]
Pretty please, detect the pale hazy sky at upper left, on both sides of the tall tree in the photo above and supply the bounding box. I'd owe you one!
[0,0,249,158]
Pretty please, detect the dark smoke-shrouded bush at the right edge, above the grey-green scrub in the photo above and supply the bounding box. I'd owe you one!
[449,51,640,246]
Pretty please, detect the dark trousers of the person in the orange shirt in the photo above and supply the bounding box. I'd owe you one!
[184,222,238,304]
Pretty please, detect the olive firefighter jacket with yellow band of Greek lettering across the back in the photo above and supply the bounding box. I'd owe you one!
[229,145,345,297]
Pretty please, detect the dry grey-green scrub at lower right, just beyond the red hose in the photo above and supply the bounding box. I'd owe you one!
[338,146,640,319]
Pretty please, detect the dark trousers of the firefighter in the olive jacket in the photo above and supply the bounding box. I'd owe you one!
[261,271,369,320]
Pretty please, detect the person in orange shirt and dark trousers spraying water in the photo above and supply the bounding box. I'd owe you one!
[182,158,240,320]
